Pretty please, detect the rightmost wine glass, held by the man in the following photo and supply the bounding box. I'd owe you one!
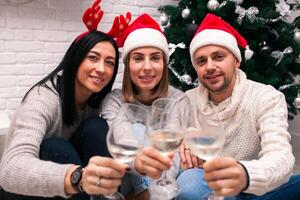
[185,104,225,200]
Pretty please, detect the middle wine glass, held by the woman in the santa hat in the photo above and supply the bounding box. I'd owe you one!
[147,98,184,199]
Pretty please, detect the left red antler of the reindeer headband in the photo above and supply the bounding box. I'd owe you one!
[82,0,104,31]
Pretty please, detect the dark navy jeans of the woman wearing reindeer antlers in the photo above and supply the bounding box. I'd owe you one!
[0,117,110,200]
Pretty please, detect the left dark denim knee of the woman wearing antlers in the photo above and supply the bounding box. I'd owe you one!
[39,137,81,165]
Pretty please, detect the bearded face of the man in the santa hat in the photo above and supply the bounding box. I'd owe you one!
[193,45,240,101]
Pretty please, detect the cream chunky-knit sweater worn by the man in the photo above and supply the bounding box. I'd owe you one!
[187,69,295,195]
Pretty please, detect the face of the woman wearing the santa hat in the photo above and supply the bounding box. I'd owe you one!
[129,47,164,93]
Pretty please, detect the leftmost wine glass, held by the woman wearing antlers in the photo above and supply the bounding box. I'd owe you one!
[91,103,148,200]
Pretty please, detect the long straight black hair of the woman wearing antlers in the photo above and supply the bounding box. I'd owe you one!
[22,31,119,126]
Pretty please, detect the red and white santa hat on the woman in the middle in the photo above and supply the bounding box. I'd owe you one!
[116,14,169,62]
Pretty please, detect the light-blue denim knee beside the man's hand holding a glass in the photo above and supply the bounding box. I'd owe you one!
[176,169,212,200]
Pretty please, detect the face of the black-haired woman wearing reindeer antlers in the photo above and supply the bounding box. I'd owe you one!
[75,41,116,101]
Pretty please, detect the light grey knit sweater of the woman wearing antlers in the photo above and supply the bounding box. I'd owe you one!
[0,83,99,197]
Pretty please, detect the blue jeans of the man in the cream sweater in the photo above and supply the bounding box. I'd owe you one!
[176,169,300,200]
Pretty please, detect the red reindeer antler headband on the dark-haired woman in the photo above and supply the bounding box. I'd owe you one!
[76,0,131,42]
